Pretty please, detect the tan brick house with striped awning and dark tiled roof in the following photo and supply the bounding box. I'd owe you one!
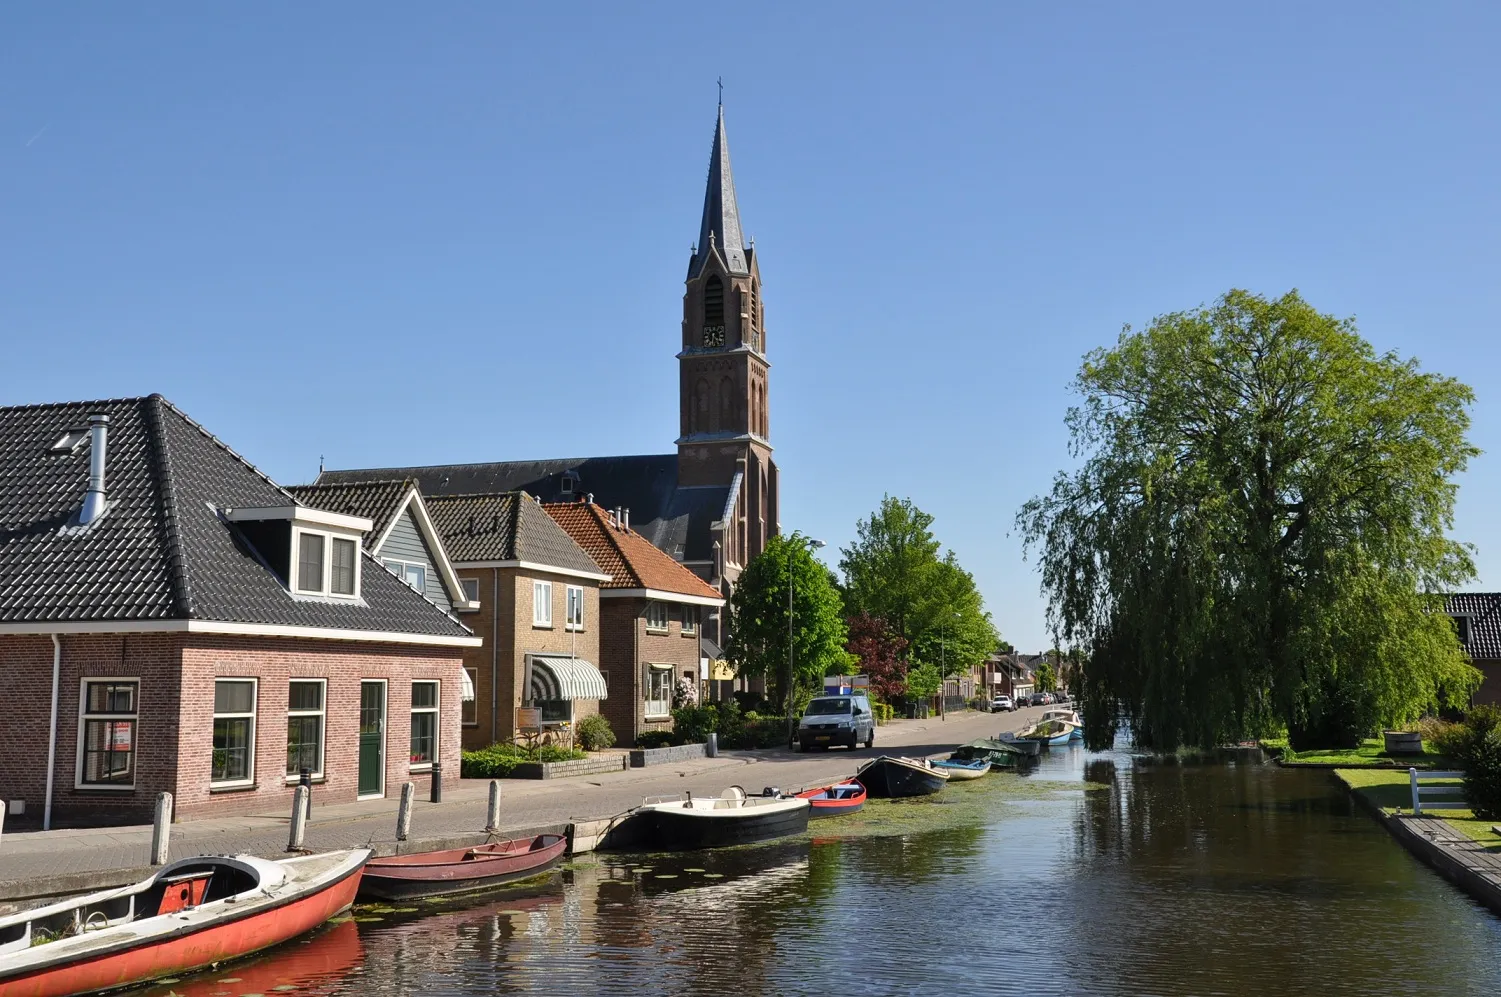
[423,491,609,748]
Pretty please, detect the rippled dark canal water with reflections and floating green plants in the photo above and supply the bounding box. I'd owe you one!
[126,748,1501,997]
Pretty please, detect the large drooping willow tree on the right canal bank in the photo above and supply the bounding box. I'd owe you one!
[1018,291,1478,749]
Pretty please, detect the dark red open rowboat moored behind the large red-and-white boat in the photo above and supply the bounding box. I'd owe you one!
[354,835,567,900]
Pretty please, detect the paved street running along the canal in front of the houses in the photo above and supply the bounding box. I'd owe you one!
[0,709,1042,904]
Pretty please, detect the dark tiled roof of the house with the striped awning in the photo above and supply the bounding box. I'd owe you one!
[425,491,605,574]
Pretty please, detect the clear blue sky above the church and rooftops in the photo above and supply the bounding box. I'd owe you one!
[0,3,1501,649]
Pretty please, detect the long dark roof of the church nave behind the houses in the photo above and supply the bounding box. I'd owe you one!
[318,453,729,562]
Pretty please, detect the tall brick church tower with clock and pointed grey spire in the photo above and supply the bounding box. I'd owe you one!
[677,105,778,565]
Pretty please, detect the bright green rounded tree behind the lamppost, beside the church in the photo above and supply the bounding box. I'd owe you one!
[725,533,853,709]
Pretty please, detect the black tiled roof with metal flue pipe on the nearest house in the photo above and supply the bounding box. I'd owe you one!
[0,395,470,637]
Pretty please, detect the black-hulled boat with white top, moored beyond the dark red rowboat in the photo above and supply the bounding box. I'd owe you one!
[638,785,812,851]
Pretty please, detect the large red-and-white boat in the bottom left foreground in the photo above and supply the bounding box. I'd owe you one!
[0,848,371,997]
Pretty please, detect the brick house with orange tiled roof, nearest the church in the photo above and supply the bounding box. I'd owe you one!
[543,502,725,745]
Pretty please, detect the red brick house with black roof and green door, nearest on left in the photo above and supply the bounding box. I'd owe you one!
[0,395,479,826]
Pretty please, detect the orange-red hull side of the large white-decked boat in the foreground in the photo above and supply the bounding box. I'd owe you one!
[0,853,368,997]
